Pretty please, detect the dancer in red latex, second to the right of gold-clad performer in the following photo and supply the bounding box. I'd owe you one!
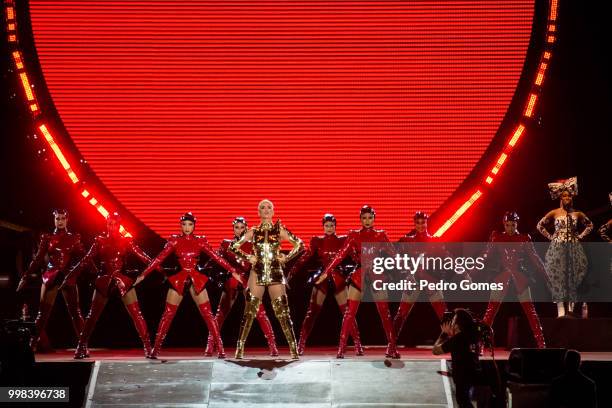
[316,205,400,358]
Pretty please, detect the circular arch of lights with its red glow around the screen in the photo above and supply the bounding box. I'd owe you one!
[4,0,558,241]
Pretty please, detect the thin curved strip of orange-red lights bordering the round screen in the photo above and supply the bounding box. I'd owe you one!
[5,0,558,237]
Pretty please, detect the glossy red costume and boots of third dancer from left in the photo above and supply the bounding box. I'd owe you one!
[142,234,239,358]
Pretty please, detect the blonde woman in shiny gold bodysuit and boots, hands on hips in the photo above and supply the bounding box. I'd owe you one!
[230,200,304,359]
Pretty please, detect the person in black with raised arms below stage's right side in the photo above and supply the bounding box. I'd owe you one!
[433,309,481,408]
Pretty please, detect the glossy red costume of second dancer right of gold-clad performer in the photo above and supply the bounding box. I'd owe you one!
[323,227,400,358]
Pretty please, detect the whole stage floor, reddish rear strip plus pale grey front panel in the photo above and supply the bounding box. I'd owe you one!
[22,346,612,407]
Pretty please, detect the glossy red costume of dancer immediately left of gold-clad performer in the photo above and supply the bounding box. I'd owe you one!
[205,237,278,357]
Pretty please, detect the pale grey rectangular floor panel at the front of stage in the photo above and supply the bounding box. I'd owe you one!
[86,359,452,408]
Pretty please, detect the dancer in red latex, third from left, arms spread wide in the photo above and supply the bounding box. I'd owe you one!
[134,212,241,359]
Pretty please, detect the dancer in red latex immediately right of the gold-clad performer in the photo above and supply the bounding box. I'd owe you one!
[289,214,363,356]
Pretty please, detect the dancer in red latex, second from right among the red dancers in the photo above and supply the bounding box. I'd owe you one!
[393,211,446,337]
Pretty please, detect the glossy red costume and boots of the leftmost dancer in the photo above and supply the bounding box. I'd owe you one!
[26,229,83,345]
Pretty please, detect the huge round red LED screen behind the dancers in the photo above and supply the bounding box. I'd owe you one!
[29,0,534,242]
